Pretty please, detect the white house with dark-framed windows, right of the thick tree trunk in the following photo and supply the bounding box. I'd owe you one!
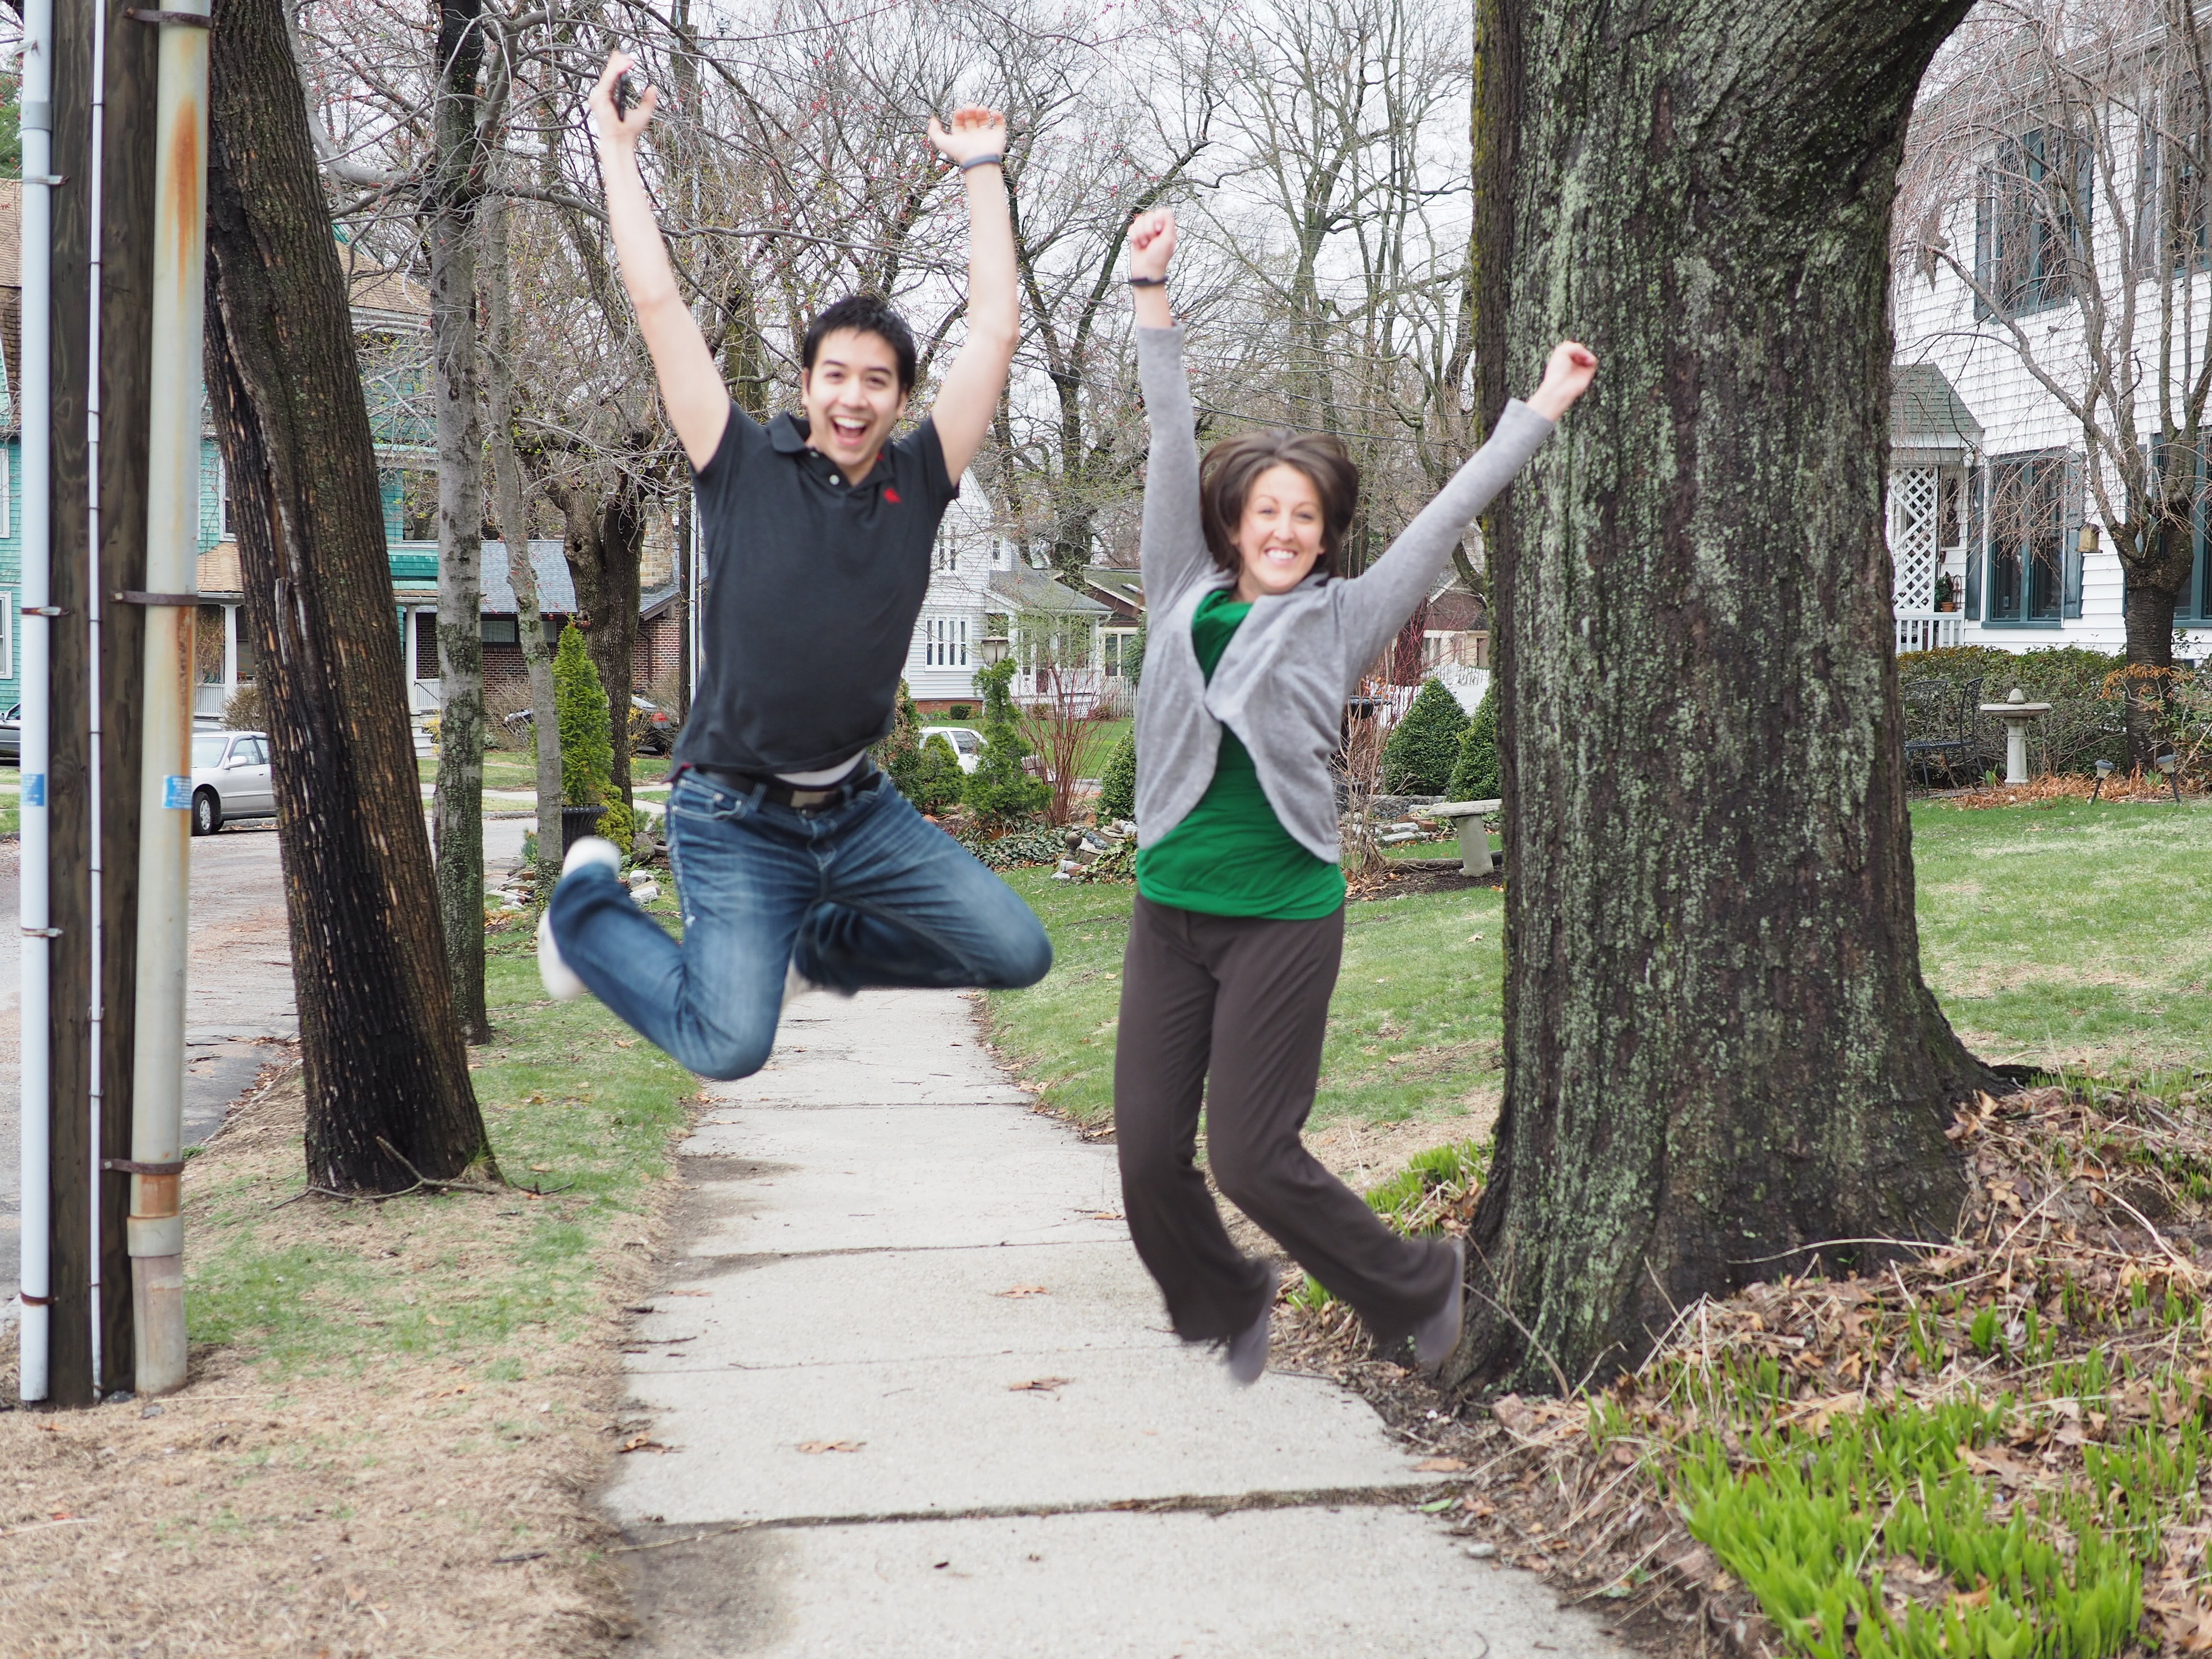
[1889,48,2212,657]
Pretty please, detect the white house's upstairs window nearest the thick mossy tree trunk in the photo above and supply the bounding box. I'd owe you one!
[1973,126,2092,321]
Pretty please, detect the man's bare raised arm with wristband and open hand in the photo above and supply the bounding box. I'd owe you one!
[929,108,1022,484]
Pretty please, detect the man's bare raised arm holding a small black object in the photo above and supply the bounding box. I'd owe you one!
[590,51,725,478]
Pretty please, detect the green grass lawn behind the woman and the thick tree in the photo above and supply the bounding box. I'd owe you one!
[989,801,2212,1121]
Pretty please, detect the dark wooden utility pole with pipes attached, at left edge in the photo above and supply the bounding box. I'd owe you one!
[42,0,155,1405]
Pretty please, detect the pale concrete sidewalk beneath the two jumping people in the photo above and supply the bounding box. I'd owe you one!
[606,991,1622,1659]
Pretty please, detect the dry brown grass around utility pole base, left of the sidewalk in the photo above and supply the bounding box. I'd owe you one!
[0,1035,674,1659]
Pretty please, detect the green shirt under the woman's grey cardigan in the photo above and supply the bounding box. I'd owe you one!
[1137,589,1345,923]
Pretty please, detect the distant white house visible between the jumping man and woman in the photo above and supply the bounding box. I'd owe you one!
[907,473,1121,714]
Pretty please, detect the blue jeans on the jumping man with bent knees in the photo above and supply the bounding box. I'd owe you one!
[549,772,1053,1077]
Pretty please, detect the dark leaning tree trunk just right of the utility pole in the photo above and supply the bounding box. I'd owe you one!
[206,0,491,1192]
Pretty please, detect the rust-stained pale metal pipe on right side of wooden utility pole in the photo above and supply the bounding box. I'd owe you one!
[128,0,208,1394]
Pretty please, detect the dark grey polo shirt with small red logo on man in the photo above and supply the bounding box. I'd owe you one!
[677,413,960,774]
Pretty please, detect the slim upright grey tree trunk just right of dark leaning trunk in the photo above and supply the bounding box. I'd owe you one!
[422,0,491,1042]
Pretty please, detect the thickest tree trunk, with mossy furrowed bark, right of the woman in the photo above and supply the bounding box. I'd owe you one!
[1449,0,1989,1389]
